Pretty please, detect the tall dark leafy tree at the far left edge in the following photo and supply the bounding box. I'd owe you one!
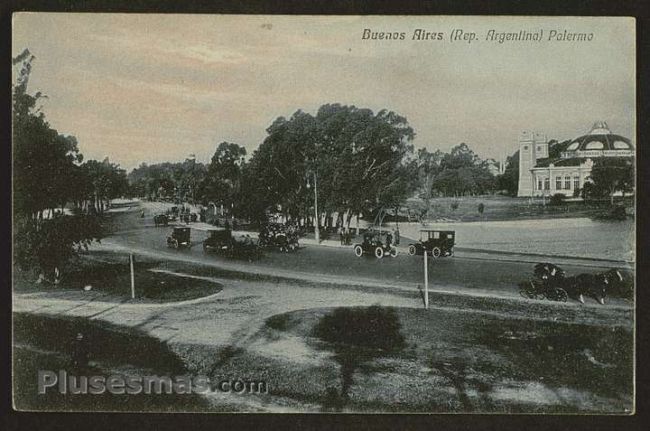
[12,50,102,280]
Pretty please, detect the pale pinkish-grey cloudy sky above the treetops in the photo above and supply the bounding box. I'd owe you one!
[13,13,636,169]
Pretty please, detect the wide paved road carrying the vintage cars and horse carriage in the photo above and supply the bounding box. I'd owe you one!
[104,203,632,302]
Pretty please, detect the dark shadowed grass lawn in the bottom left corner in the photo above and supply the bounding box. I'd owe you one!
[13,314,210,412]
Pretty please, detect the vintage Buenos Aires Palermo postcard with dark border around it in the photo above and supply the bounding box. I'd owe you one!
[12,12,637,415]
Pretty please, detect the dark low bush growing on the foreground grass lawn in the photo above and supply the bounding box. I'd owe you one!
[314,305,404,351]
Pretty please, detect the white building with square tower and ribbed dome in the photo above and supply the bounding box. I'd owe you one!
[517,121,634,197]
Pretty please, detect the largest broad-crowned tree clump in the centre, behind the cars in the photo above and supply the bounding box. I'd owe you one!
[238,104,415,228]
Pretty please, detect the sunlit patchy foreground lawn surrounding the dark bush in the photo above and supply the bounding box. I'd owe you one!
[209,308,633,414]
